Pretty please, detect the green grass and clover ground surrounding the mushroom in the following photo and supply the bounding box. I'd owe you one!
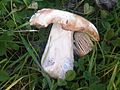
[0,0,120,90]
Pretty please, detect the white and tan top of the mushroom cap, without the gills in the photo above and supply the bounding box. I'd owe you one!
[30,8,100,41]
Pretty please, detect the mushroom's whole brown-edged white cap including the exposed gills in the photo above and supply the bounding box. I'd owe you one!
[30,8,100,56]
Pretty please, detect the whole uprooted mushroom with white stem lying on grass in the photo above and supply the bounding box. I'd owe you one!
[30,8,99,79]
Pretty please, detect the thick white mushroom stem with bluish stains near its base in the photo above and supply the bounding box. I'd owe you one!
[41,24,74,79]
